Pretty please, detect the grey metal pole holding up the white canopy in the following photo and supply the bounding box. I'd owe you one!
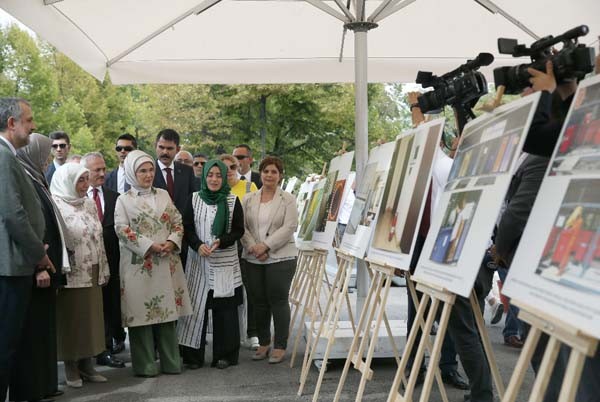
[345,22,377,315]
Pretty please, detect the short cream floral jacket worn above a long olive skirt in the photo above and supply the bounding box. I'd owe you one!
[52,196,110,288]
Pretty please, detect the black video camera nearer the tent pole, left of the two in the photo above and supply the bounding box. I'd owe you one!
[416,53,494,132]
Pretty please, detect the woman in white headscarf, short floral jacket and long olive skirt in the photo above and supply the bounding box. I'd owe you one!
[50,163,110,388]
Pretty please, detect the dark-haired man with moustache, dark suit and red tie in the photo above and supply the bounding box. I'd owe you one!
[153,128,200,268]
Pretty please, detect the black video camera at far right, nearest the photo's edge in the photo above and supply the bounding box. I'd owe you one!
[494,25,595,94]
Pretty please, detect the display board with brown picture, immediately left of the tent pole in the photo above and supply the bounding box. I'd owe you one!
[312,152,354,250]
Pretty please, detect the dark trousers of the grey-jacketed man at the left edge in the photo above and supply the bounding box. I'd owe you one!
[0,275,33,401]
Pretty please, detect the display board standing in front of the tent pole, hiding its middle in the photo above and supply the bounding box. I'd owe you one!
[340,141,396,258]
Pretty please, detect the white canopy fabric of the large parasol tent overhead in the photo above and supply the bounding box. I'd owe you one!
[0,0,600,84]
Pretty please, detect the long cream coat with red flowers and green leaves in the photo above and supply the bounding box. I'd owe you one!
[115,188,192,327]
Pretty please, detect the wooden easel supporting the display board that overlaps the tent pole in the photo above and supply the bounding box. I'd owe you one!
[298,249,355,401]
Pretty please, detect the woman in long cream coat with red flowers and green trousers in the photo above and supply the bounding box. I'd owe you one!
[115,150,191,377]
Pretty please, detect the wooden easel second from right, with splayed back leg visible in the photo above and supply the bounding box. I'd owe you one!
[387,282,504,402]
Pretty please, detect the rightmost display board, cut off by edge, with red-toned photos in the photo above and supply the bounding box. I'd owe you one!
[503,76,600,338]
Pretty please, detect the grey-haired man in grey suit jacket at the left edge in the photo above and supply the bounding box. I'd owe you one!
[0,98,54,401]
